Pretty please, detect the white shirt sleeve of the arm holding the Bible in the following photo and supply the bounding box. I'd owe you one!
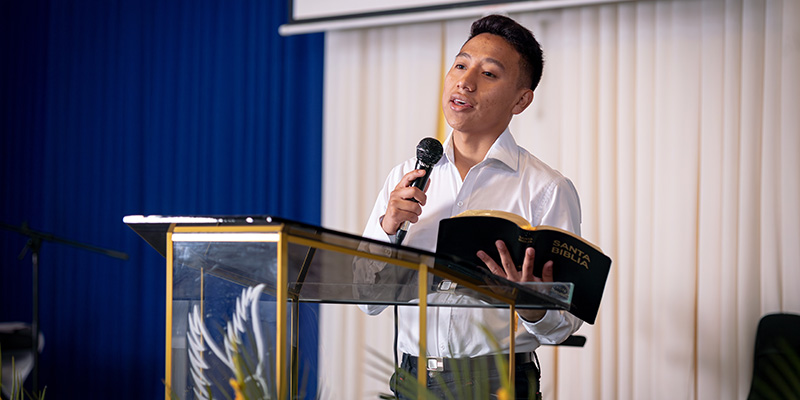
[520,177,583,344]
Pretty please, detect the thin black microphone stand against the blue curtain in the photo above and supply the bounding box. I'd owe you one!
[0,222,128,394]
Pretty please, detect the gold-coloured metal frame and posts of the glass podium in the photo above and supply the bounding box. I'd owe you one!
[125,216,571,399]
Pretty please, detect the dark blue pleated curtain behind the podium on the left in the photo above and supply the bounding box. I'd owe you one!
[0,0,324,399]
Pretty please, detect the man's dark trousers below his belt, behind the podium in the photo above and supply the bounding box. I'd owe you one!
[391,354,541,400]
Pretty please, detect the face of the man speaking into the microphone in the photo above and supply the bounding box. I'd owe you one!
[442,33,533,135]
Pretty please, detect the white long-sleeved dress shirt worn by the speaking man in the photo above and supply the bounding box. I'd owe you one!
[356,129,582,357]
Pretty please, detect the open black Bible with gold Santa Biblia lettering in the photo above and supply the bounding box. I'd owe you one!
[436,210,611,324]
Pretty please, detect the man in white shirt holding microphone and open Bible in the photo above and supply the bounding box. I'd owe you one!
[356,15,581,399]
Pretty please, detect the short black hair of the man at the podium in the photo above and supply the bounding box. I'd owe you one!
[467,15,544,90]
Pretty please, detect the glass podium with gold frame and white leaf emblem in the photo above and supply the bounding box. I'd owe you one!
[123,215,573,399]
